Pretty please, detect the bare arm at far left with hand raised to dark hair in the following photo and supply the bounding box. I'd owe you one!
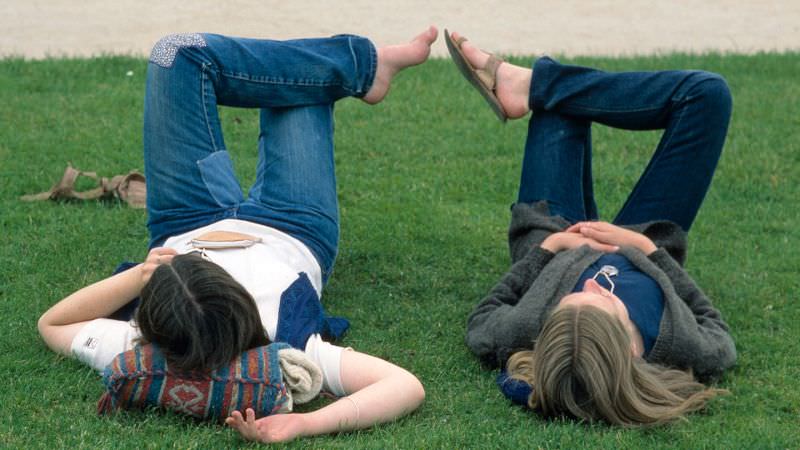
[38,248,175,355]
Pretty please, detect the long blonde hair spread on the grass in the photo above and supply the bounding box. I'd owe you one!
[508,305,727,427]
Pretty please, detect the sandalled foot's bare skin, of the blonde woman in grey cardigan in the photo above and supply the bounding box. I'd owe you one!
[451,32,533,119]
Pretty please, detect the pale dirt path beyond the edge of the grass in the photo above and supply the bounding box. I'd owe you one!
[0,0,800,58]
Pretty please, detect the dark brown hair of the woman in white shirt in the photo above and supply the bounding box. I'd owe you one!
[136,253,269,371]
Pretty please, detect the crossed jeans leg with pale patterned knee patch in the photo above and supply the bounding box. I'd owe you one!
[144,34,377,245]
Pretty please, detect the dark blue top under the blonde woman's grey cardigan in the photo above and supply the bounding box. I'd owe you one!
[572,253,664,355]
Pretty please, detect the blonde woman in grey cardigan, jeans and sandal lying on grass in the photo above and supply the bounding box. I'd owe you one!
[445,31,736,426]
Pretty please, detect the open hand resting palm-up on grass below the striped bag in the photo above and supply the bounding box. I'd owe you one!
[225,408,306,443]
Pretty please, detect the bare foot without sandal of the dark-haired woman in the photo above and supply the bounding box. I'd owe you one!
[361,25,439,105]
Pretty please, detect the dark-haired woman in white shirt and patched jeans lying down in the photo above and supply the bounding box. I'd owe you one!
[39,27,437,442]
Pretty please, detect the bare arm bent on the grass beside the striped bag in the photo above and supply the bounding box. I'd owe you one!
[226,351,425,442]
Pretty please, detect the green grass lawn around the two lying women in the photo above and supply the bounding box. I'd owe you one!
[0,53,800,449]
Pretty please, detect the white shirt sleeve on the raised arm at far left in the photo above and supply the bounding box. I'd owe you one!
[71,319,140,372]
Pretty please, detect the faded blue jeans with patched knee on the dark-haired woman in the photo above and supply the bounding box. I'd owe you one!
[144,34,377,280]
